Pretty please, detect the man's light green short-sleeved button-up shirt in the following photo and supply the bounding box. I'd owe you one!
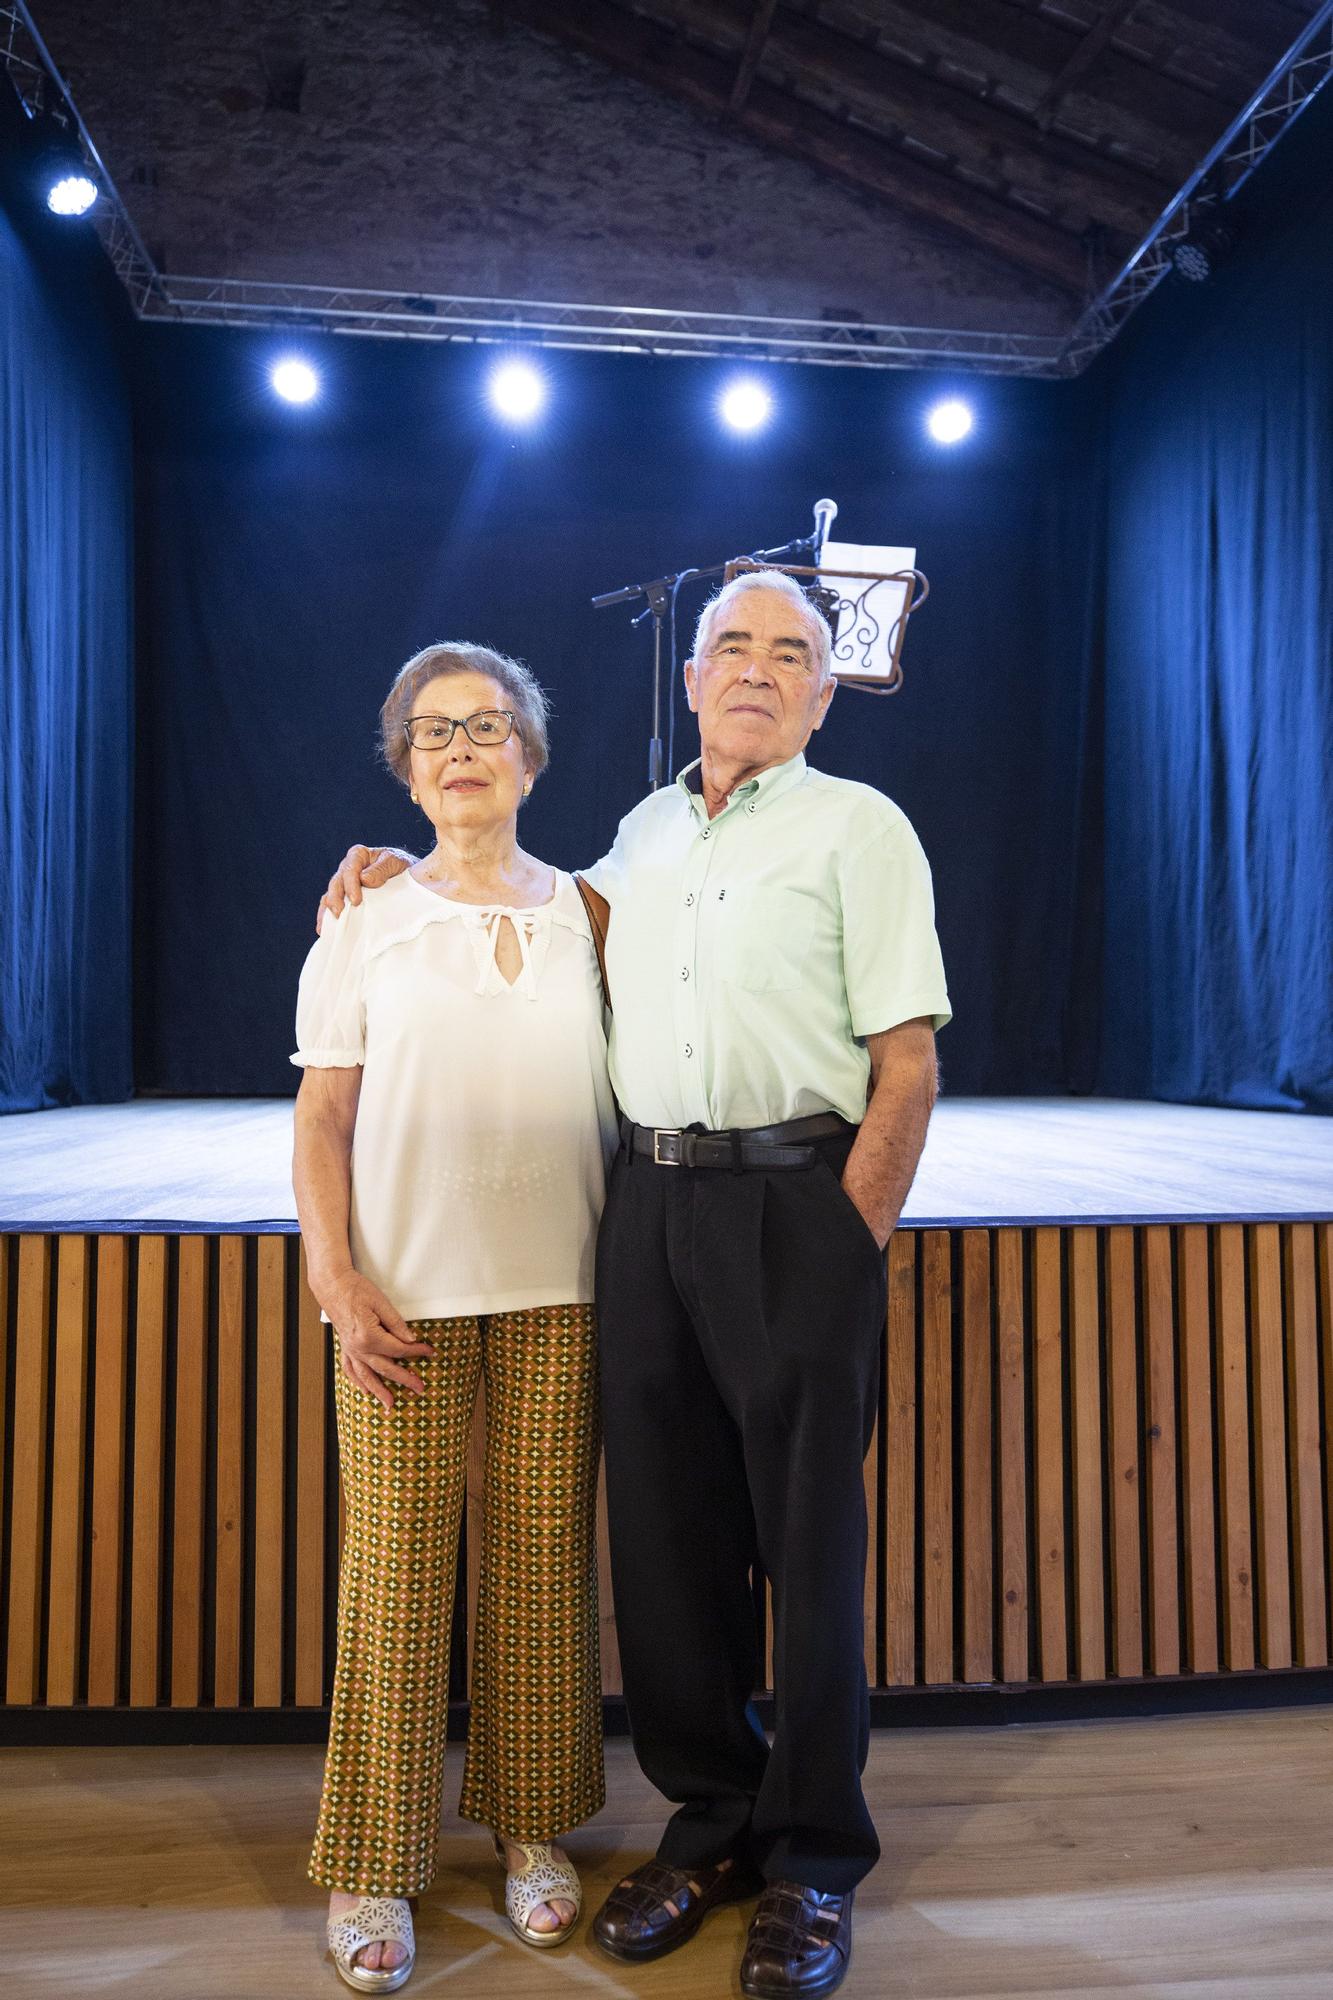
[586,756,949,1132]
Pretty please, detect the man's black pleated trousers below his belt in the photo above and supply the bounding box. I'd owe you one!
[596,1138,887,1892]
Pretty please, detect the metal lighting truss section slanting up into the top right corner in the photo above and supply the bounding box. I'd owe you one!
[1055,0,1333,374]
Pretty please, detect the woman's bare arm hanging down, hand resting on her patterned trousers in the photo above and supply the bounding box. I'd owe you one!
[292,1068,434,1410]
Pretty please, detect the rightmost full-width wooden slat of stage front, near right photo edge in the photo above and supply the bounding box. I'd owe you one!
[1283,1222,1329,1666]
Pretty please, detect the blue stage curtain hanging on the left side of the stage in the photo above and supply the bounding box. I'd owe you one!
[0,141,134,1112]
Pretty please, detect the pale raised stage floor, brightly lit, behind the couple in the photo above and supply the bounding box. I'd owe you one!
[0,1098,1333,1232]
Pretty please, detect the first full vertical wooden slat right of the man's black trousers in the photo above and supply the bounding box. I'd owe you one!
[885,1230,919,1688]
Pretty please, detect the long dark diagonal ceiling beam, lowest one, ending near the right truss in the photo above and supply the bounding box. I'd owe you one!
[492,0,1085,298]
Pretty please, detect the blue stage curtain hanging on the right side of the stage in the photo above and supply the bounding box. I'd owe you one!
[1101,90,1333,1112]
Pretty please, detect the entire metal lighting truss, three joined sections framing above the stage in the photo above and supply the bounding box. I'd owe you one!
[0,0,1333,378]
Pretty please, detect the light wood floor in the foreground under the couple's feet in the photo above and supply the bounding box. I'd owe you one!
[0,1708,1333,2000]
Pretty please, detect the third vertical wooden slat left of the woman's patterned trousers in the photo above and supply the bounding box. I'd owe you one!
[212,1236,246,1708]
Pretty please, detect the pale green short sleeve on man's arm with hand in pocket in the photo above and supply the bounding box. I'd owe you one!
[839,814,951,1038]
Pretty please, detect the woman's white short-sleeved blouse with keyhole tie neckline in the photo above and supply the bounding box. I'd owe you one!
[292,872,616,1320]
